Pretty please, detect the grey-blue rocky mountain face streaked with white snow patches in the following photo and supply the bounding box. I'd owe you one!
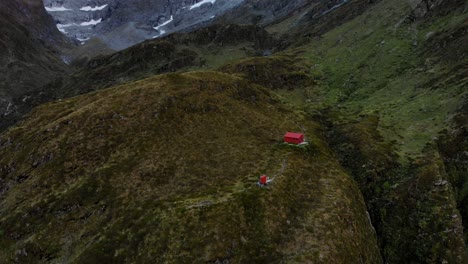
[44,0,243,50]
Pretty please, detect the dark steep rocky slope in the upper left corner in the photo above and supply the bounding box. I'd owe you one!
[0,0,71,131]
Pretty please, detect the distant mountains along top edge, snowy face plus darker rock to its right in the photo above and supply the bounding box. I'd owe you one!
[44,0,348,50]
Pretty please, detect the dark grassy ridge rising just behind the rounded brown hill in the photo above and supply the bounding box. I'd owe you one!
[0,25,274,132]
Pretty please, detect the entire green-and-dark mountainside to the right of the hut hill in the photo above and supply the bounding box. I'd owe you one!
[260,0,468,263]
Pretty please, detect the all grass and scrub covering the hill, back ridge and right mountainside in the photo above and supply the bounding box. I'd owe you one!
[0,0,468,263]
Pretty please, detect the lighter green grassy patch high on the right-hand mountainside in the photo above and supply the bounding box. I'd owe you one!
[294,0,468,159]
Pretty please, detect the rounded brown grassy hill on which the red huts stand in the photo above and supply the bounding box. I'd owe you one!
[0,72,381,263]
